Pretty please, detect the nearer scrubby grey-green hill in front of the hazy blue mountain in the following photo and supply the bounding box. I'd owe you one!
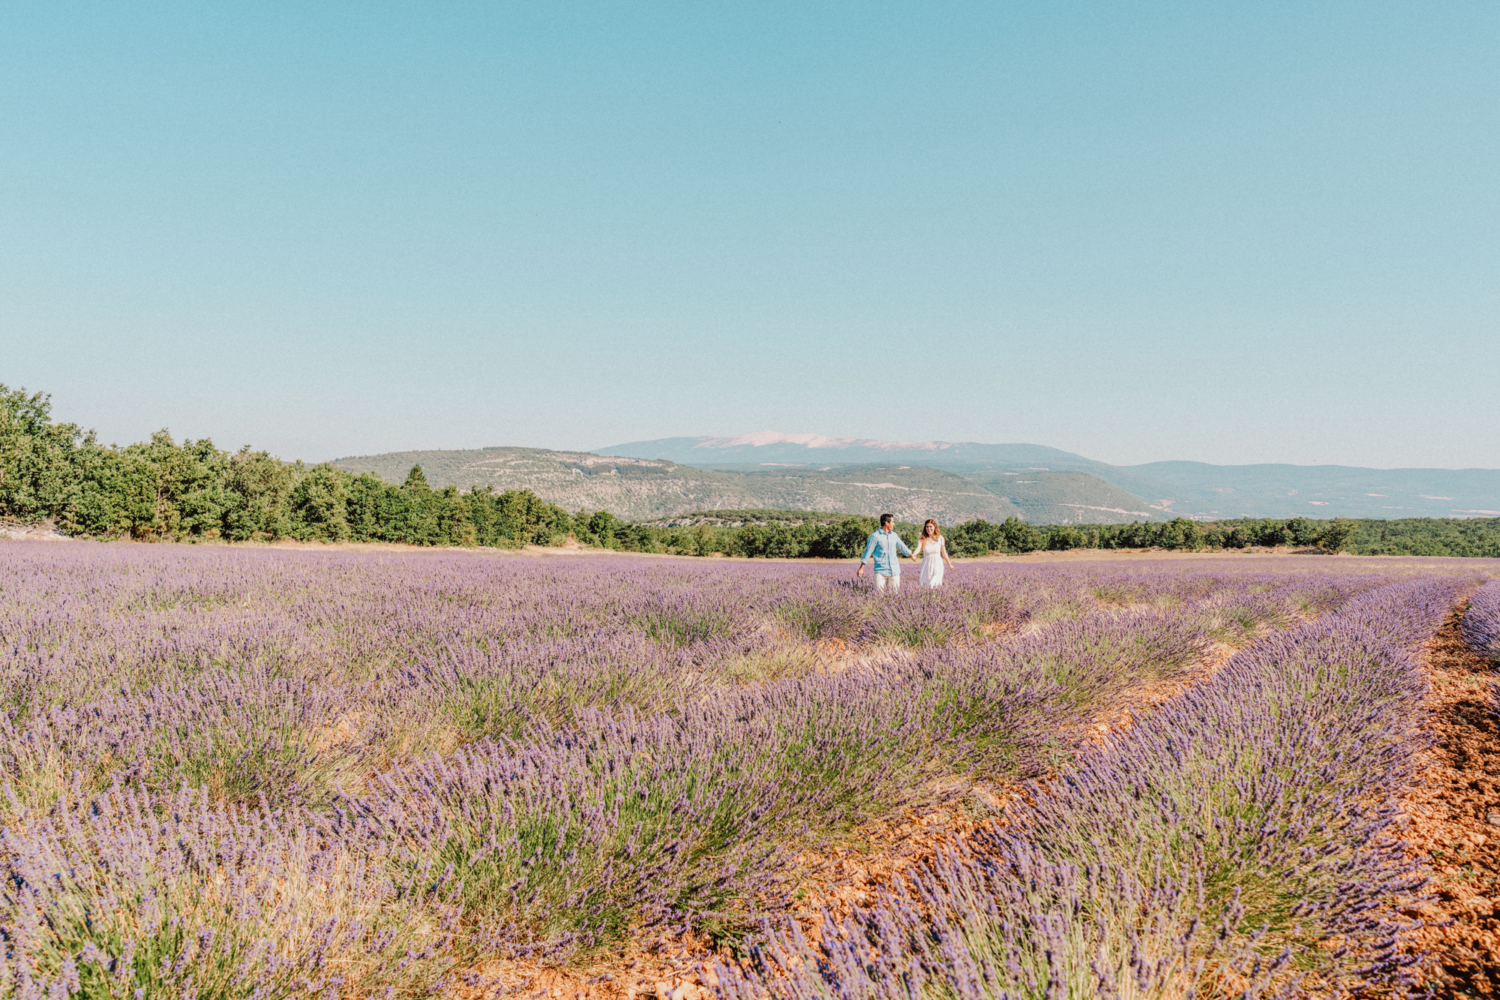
[333,448,1026,523]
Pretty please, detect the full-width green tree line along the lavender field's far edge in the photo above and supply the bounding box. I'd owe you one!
[0,384,1500,559]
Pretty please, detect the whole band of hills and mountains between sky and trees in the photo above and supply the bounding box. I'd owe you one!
[333,432,1500,523]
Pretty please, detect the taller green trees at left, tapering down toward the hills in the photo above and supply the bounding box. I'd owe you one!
[0,385,603,547]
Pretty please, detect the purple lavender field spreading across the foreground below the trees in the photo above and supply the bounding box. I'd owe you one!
[0,543,1496,1000]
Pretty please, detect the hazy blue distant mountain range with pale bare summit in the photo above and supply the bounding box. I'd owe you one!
[602,432,1500,523]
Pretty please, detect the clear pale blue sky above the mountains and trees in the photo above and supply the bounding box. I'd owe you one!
[0,0,1500,468]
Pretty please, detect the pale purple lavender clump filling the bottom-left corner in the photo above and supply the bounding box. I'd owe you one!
[0,786,459,999]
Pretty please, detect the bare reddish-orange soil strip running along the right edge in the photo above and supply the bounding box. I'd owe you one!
[1404,615,1500,997]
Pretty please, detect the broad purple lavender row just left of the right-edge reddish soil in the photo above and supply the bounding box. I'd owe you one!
[719,580,1463,1000]
